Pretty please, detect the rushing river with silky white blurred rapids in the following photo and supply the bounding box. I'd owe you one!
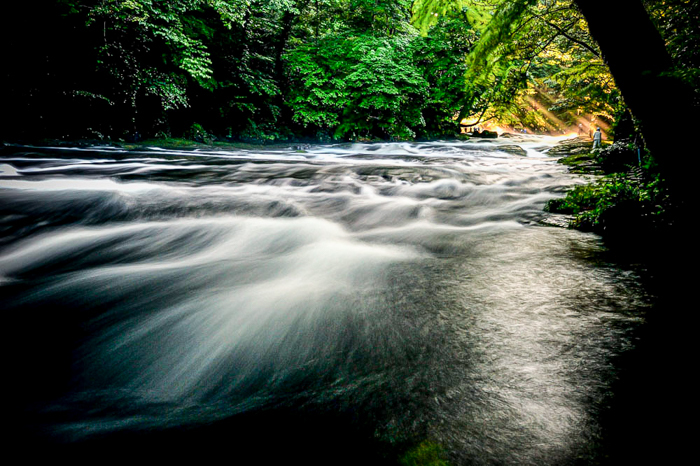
[0,136,650,465]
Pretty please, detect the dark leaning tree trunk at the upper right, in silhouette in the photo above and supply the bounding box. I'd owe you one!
[575,0,700,201]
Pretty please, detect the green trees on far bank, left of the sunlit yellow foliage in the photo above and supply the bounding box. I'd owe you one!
[0,0,477,140]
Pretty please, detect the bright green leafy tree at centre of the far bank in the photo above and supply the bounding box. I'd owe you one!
[285,0,477,139]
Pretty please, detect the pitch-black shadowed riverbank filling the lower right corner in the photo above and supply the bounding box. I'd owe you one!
[600,230,698,465]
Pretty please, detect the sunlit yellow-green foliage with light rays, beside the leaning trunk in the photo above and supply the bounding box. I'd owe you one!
[414,0,619,131]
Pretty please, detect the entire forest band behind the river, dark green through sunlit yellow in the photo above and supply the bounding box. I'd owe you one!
[0,0,700,142]
